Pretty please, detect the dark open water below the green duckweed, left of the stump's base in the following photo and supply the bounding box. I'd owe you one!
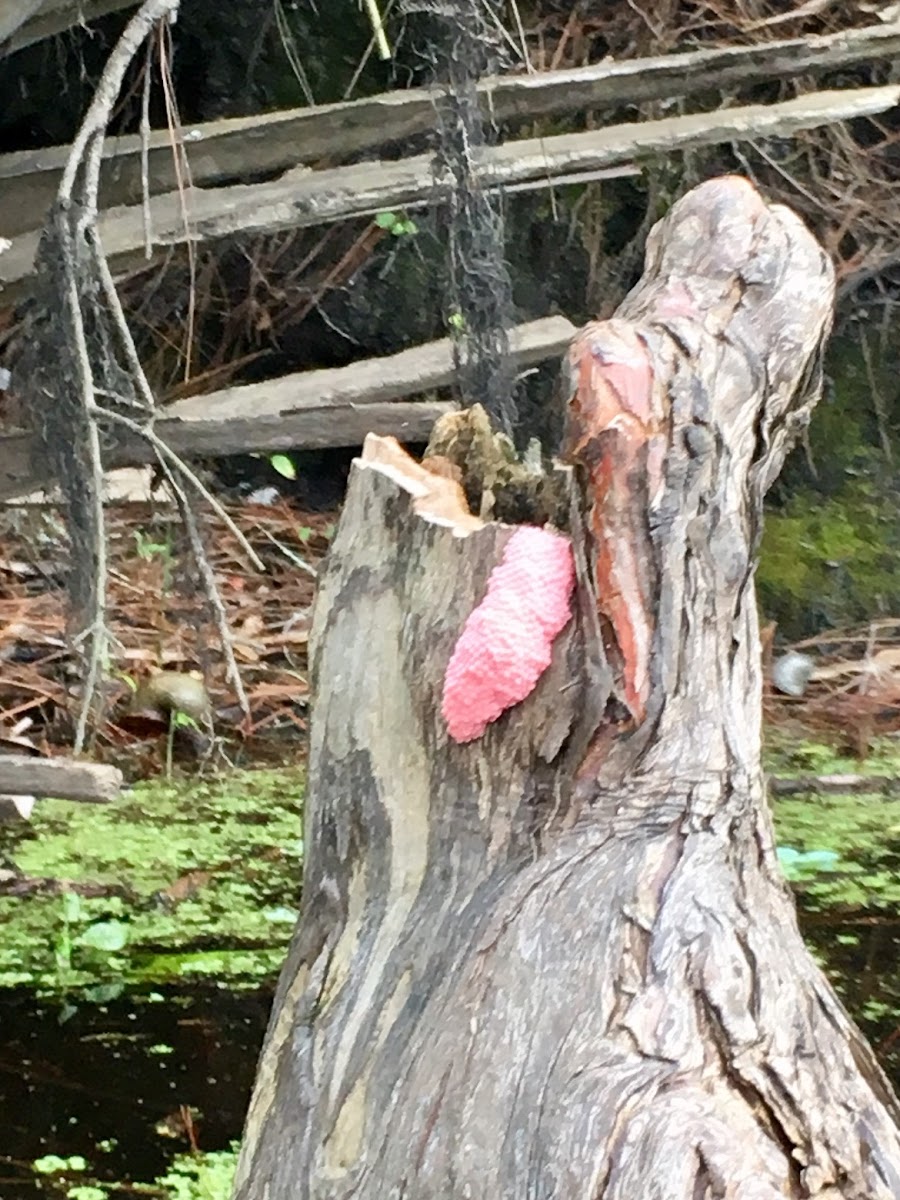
[0,988,271,1200]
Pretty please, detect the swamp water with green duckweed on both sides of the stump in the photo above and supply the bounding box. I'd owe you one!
[0,743,900,1200]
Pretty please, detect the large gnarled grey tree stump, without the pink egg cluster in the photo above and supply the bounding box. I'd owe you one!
[235,178,900,1200]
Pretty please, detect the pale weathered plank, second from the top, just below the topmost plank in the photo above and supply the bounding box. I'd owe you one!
[0,86,900,304]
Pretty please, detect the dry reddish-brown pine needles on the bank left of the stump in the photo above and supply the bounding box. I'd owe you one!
[0,500,336,752]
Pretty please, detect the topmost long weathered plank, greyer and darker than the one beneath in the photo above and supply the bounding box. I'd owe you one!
[0,21,900,238]
